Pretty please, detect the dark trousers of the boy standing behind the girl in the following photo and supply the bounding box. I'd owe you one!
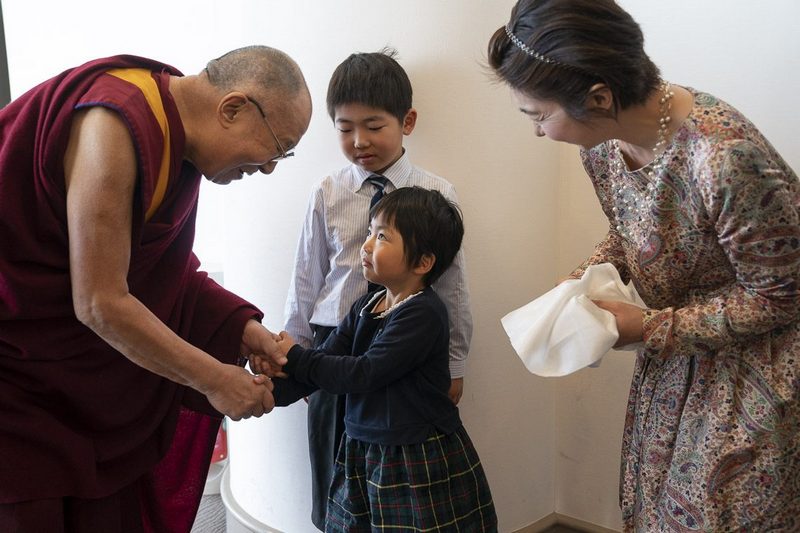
[308,324,345,531]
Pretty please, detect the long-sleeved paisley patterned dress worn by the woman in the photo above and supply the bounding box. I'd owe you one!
[573,89,800,532]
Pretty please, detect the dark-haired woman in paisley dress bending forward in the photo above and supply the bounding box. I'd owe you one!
[489,0,800,532]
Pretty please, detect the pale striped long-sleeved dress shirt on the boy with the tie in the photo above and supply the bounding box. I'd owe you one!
[284,153,472,378]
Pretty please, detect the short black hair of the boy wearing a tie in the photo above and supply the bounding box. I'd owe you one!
[327,48,412,124]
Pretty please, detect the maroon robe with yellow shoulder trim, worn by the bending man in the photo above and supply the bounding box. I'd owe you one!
[0,56,261,530]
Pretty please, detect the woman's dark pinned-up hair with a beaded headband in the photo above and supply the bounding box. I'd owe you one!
[488,0,660,120]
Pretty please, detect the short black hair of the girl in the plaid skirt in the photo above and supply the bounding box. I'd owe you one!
[369,187,464,286]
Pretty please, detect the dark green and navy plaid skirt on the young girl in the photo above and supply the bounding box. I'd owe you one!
[325,426,497,533]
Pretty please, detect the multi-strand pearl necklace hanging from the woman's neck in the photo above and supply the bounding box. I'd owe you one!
[608,80,675,239]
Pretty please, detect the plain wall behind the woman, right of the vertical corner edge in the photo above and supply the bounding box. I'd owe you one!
[556,0,800,528]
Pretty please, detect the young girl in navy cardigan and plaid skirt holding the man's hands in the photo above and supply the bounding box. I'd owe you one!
[260,187,497,532]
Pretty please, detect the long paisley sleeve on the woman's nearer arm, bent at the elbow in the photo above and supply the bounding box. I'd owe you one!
[644,141,800,357]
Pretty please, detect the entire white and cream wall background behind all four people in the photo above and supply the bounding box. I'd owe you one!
[3,0,800,532]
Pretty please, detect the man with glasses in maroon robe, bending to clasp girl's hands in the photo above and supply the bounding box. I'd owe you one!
[0,47,311,532]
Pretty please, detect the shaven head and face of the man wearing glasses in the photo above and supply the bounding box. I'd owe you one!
[175,46,311,183]
